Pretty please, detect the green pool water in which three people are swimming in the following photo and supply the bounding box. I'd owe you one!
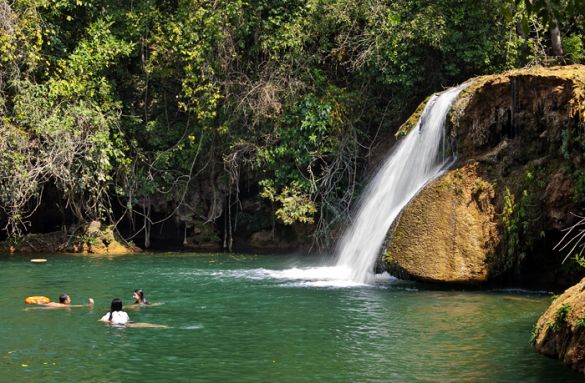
[0,254,582,382]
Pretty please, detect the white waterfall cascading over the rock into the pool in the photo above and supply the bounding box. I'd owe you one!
[336,84,467,283]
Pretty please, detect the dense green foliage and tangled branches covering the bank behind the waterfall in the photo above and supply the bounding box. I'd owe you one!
[0,0,585,247]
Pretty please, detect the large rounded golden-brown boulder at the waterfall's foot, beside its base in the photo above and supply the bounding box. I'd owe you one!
[385,163,501,283]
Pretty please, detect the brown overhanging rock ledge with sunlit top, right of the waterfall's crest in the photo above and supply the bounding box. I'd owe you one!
[450,65,585,152]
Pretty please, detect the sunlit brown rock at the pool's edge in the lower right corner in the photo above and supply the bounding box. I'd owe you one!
[532,278,585,373]
